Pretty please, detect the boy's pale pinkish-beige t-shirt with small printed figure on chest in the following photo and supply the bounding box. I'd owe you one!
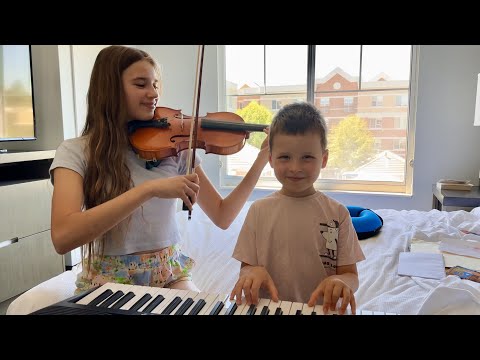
[233,192,365,303]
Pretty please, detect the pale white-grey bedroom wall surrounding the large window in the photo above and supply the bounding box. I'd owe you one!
[9,45,480,210]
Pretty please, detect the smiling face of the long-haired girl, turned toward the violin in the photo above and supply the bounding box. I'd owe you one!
[122,60,158,120]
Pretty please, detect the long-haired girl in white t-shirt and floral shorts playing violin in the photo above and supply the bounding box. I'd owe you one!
[50,45,269,294]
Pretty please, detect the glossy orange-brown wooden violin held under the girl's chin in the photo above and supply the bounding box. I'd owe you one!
[128,107,268,161]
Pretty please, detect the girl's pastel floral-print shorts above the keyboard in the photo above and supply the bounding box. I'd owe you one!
[75,245,195,294]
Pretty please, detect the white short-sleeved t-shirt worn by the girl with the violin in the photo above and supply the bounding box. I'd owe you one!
[50,137,201,255]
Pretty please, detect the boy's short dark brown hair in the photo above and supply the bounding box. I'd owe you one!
[268,102,327,151]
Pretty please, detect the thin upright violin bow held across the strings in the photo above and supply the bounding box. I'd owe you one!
[183,45,205,220]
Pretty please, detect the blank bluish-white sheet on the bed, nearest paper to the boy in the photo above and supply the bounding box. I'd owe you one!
[398,252,445,279]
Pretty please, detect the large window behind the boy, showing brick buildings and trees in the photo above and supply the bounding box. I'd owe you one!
[219,45,417,194]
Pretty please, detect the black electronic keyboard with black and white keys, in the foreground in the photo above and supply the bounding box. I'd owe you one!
[31,283,397,315]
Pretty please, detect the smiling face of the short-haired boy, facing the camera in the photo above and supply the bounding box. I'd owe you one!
[270,133,328,197]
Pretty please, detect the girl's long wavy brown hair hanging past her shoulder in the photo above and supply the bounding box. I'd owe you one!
[82,45,160,271]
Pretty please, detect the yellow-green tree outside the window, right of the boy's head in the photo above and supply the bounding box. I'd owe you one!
[328,115,374,171]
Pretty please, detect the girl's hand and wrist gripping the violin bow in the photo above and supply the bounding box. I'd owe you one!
[146,173,200,210]
